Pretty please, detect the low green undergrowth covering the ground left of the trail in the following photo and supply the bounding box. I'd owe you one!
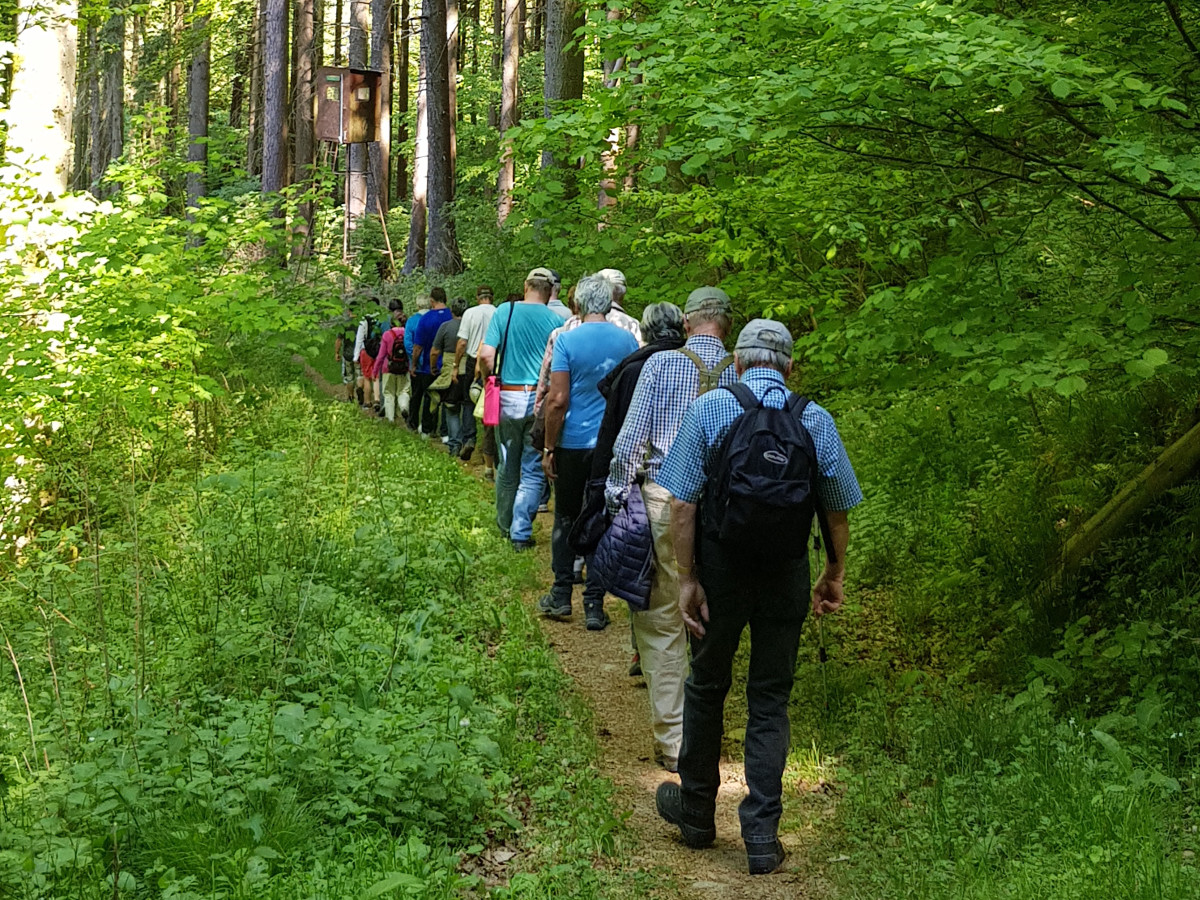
[0,360,624,898]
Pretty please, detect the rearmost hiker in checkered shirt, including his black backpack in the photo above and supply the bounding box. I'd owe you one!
[655,319,863,875]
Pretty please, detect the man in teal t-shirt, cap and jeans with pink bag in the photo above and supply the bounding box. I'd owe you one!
[479,268,563,551]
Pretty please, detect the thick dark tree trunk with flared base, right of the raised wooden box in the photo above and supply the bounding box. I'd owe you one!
[421,0,462,274]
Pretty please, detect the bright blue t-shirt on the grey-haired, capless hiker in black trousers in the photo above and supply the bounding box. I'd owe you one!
[550,322,637,450]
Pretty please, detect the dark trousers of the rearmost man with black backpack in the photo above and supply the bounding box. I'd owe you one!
[679,541,810,842]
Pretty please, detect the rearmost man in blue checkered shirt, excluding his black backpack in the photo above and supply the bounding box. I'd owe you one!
[656,319,863,875]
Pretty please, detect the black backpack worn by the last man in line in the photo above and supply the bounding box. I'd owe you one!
[701,383,833,560]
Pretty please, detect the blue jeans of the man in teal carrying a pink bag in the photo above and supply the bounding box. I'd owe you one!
[496,391,546,541]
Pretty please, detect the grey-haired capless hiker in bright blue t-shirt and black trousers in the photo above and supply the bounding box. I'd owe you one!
[538,276,637,631]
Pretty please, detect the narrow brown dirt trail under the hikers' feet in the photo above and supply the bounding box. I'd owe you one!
[293,356,835,900]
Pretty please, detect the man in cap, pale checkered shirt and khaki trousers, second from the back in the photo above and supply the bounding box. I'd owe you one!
[605,287,736,772]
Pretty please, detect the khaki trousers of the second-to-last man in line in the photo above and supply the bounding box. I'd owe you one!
[632,481,688,757]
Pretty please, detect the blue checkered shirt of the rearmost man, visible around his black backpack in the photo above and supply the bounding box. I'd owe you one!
[655,367,863,511]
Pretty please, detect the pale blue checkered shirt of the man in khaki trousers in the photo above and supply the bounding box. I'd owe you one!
[605,335,737,512]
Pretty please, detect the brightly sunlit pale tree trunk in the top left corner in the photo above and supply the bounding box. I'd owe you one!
[7,0,78,194]
